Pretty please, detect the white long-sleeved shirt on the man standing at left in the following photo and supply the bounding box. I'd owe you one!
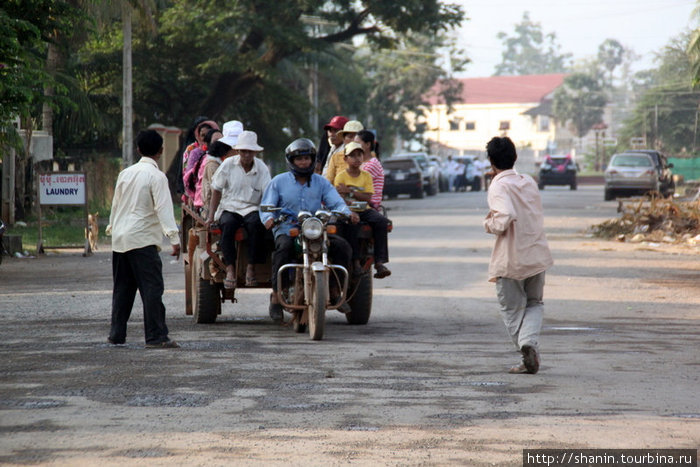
[107,157,180,253]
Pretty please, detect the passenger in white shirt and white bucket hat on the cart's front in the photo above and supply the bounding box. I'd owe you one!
[207,131,270,289]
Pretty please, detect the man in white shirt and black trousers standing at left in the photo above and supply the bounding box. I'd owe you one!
[107,130,180,349]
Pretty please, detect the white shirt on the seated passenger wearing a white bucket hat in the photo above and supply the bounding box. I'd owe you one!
[211,156,270,219]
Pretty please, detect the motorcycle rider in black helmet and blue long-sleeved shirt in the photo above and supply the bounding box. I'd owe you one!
[260,138,359,320]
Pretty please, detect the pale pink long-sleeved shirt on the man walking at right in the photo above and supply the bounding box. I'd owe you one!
[484,169,553,282]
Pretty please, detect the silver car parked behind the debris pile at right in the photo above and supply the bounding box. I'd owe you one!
[605,153,659,201]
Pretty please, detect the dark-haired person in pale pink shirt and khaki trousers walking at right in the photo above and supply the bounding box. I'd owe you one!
[484,137,553,374]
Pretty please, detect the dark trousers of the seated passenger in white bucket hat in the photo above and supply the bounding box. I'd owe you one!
[219,211,267,264]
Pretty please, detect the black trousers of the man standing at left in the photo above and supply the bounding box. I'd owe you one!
[109,245,168,344]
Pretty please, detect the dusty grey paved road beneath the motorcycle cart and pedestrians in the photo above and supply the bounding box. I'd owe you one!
[0,186,700,465]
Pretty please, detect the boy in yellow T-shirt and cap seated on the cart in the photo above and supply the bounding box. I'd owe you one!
[335,141,391,279]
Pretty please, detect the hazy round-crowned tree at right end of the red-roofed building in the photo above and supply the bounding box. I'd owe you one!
[552,73,607,138]
